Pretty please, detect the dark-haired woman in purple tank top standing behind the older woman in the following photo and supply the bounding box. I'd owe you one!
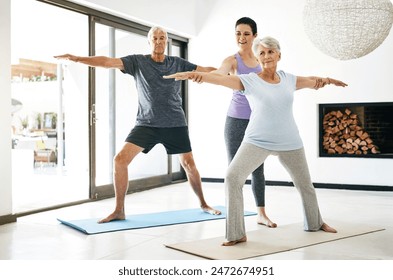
[214,17,277,227]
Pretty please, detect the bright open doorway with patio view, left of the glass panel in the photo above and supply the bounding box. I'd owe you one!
[11,0,89,214]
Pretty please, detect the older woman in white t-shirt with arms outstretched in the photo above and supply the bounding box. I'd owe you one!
[166,37,347,246]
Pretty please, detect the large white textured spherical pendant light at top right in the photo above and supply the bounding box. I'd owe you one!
[303,0,393,60]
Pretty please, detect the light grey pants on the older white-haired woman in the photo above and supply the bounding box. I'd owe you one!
[225,142,323,241]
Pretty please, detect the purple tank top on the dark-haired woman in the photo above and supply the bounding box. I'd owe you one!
[227,53,262,119]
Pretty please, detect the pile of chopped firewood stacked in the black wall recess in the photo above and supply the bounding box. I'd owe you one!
[322,108,380,155]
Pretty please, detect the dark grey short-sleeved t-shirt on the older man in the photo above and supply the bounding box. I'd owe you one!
[121,54,197,127]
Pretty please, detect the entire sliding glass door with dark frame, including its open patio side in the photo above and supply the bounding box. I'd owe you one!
[10,0,187,215]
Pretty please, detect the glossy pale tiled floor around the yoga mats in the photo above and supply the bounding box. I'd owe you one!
[0,183,393,260]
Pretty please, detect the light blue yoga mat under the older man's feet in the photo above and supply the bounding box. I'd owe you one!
[57,206,256,234]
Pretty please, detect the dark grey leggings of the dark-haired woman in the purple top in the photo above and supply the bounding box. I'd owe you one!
[224,116,265,207]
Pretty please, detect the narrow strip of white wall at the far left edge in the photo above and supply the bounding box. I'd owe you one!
[0,0,12,216]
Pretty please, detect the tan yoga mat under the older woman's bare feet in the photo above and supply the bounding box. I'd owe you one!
[165,221,384,260]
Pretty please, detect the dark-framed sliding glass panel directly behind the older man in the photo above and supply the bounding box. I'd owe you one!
[91,18,185,199]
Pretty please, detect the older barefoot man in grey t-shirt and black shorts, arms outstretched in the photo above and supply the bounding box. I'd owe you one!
[56,27,221,223]
